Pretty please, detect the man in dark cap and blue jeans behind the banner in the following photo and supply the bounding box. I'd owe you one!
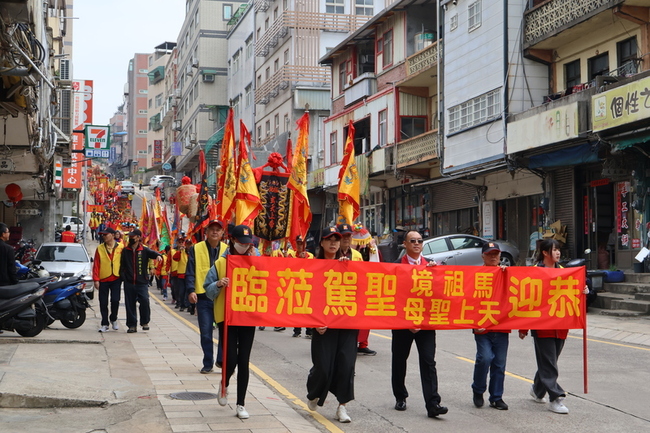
[472,242,510,410]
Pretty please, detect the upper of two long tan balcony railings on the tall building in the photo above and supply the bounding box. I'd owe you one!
[255,10,372,57]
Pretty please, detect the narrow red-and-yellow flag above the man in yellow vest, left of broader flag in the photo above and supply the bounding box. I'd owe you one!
[217,108,237,223]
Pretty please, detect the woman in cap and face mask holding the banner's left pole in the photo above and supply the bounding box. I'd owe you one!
[203,225,259,419]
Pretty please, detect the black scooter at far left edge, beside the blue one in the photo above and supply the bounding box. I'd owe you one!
[0,278,50,337]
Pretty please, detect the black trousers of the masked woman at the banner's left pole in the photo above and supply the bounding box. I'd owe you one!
[218,322,255,406]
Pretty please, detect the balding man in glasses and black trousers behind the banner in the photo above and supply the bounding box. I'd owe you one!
[391,231,448,418]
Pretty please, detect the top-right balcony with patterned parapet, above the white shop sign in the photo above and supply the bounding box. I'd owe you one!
[524,0,625,49]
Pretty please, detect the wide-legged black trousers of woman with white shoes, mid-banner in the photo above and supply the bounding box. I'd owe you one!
[307,328,359,406]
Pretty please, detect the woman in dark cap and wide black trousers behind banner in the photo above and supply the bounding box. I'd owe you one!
[307,227,359,422]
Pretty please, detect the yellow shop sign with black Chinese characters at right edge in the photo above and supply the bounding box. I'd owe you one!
[591,77,650,132]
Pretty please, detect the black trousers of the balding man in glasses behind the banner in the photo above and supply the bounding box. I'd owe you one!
[391,329,440,410]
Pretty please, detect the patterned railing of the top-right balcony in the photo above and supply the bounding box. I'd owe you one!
[524,0,624,48]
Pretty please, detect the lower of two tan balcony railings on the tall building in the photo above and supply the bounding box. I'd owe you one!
[255,65,330,104]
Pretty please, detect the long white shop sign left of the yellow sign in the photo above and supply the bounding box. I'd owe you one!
[507,102,585,153]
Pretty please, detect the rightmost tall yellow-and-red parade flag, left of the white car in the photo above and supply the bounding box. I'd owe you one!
[338,120,360,224]
